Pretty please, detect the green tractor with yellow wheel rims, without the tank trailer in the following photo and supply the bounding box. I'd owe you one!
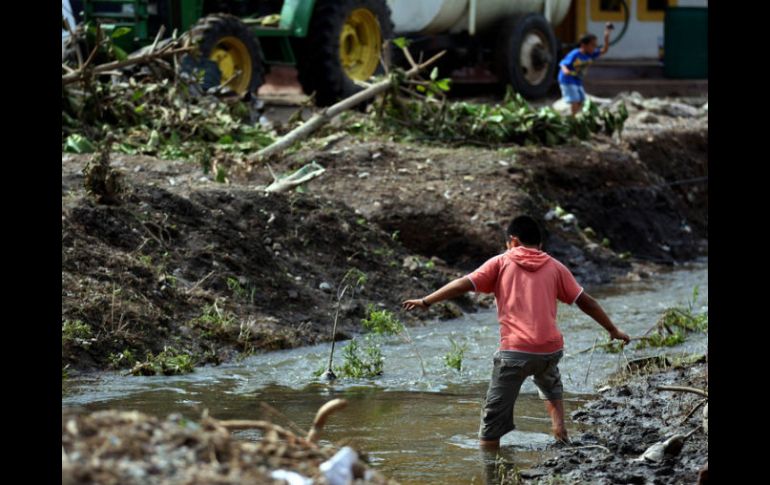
[83,0,393,106]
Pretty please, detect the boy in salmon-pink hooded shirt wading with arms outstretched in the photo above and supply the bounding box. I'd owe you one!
[402,216,631,448]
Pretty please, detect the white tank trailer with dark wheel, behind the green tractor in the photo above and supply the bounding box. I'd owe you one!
[387,0,572,98]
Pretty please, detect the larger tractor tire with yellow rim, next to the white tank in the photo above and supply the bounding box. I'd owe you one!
[297,0,393,106]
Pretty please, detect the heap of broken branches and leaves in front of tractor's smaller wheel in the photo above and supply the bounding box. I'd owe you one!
[62,19,275,164]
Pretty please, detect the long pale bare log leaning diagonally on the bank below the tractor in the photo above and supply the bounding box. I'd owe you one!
[254,49,446,160]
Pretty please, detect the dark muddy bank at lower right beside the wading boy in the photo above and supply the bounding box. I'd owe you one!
[508,358,708,484]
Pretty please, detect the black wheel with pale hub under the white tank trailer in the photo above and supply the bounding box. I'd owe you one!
[497,13,559,99]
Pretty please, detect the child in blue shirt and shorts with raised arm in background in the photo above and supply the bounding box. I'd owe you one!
[559,22,613,116]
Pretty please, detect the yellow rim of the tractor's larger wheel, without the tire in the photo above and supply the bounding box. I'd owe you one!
[340,8,382,81]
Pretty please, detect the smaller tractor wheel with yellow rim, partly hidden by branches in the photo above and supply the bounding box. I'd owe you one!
[183,13,265,95]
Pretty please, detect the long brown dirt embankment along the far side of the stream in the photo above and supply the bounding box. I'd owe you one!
[62,119,708,370]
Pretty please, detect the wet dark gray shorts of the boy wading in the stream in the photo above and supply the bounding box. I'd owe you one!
[479,350,564,440]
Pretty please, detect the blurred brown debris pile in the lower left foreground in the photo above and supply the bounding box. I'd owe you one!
[62,400,396,485]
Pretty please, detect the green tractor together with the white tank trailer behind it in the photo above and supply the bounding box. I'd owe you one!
[83,0,571,106]
